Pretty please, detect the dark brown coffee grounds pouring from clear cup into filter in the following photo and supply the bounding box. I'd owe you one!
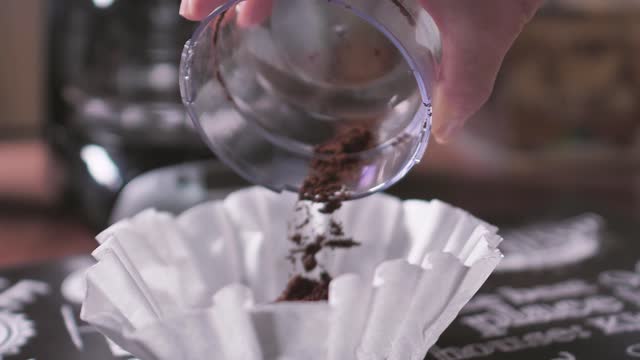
[277,126,374,301]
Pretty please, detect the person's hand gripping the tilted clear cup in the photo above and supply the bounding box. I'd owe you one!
[180,0,544,142]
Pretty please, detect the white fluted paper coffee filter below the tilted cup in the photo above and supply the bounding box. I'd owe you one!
[82,188,502,360]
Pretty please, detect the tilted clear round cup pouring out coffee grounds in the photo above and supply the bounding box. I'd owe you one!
[180,0,441,198]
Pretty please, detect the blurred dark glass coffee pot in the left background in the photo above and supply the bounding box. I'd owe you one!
[45,0,212,227]
